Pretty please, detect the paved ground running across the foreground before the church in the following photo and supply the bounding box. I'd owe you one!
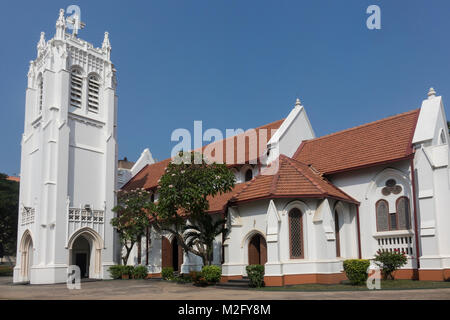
[0,277,450,300]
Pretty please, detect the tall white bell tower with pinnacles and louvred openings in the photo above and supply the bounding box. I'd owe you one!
[14,9,118,283]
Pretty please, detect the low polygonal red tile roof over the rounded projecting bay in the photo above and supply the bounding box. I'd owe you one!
[231,155,358,203]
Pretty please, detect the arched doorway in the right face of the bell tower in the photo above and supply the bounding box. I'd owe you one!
[68,227,103,279]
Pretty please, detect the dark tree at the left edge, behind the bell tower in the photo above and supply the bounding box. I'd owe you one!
[0,173,19,257]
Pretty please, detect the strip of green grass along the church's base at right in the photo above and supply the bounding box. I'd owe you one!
[253,280,450,291]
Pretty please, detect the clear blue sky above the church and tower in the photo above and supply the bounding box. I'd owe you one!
[0,0,450,175]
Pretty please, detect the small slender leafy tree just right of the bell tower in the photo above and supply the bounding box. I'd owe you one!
[111,189,150,265]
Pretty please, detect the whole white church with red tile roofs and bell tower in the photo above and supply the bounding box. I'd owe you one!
[14,11,450,286]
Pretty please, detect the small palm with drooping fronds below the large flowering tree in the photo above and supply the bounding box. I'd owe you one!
[183,214,225,266]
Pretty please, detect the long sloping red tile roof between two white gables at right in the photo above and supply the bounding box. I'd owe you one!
[293,109,420,174]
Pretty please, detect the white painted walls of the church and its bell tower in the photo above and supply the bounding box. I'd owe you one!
[14,11,450,283]
